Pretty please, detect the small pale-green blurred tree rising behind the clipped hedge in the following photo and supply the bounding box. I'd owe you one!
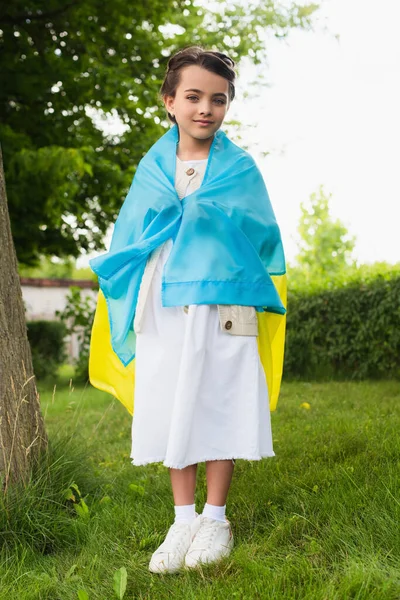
[294,186,355,285]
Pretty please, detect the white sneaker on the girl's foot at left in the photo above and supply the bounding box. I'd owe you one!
[149,513,200,573]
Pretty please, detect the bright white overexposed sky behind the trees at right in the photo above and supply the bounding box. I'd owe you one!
[79,0,400,265]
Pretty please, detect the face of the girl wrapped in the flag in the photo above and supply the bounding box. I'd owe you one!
[164,65,229,140]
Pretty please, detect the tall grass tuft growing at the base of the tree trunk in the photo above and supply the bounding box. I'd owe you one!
[0,432,99,554]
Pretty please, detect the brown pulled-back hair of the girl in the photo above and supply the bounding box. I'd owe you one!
[160,46,236,123]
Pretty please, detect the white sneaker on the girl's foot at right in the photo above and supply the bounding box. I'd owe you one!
[185,515,233,567]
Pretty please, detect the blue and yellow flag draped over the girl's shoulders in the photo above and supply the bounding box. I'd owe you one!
[89,125,286,414]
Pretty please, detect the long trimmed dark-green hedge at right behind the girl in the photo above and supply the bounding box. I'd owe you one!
[284,271,400,379]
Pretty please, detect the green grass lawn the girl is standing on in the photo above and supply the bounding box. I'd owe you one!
[0,382,400,600]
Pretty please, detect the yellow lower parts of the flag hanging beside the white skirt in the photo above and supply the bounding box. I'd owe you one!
[89,275,286,415]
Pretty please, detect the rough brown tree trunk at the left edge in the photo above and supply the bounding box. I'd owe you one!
[0,147,47,489]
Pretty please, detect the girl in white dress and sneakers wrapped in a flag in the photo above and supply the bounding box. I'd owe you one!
[90,47,286,573]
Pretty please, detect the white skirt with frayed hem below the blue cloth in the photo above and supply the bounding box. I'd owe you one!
[131,241,275,469]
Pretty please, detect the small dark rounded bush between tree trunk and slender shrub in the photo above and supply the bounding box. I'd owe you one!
[27,321,67,379]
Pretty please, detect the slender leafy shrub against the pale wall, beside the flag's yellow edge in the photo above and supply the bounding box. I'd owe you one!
[56,287,95,381]
